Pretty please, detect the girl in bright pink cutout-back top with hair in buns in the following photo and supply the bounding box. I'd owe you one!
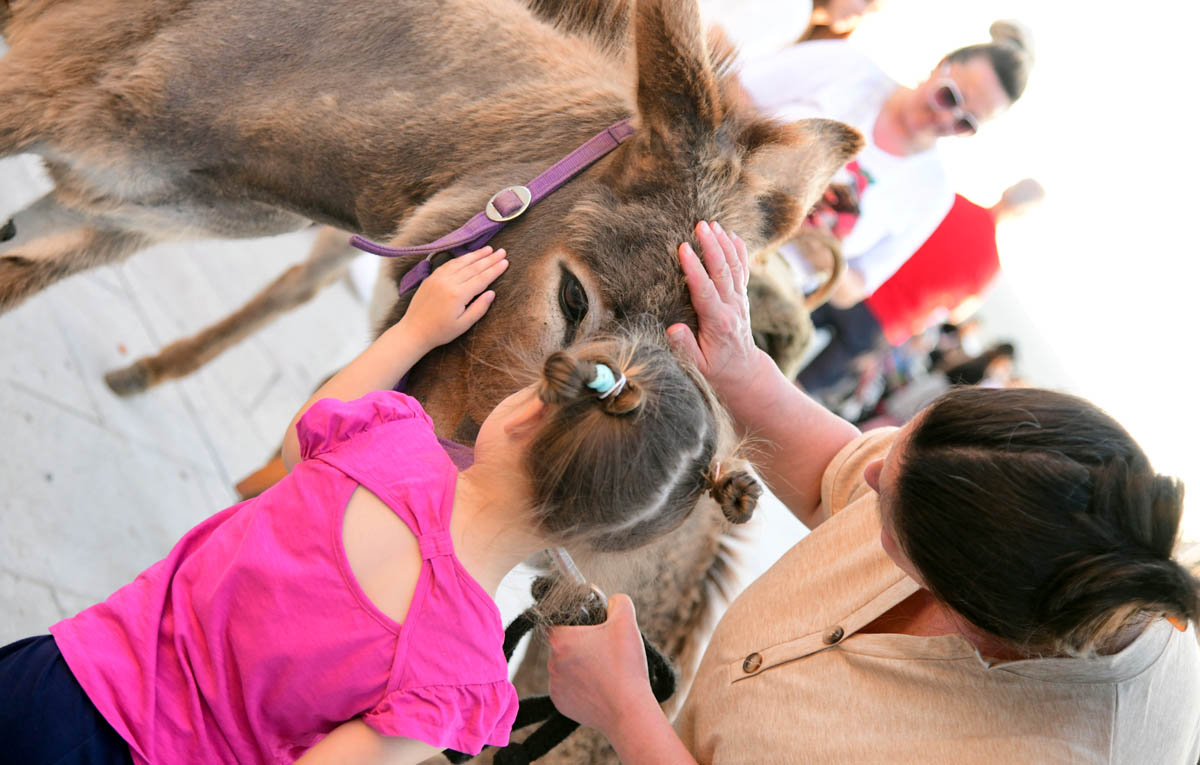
[0,241,757,764]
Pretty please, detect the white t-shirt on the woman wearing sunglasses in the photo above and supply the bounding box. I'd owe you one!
[739,40,954,294]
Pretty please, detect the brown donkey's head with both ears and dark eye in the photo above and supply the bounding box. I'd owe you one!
[379,0,862,442]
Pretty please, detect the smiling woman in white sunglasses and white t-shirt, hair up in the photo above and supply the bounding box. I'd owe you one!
[739,22,1032,307]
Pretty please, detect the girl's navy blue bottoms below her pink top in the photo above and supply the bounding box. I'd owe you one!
[0,634,133,765]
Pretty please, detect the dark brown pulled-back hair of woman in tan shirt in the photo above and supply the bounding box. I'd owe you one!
[890,388,1200,655]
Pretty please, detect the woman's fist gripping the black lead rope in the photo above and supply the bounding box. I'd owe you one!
[547,595,658,739]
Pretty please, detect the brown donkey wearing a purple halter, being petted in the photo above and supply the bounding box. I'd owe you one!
[0,0,860,762]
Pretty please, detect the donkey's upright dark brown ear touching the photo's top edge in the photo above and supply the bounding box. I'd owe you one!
[634,0,722,147]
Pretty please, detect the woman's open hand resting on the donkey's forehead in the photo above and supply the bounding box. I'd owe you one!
[667,221,760,400]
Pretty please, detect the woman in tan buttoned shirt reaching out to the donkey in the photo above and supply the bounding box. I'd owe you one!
[550,223,1200,765]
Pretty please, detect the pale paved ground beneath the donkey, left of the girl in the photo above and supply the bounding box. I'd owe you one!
[0,156,799,645]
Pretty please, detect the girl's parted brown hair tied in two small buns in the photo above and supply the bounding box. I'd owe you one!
[526,331,761,550]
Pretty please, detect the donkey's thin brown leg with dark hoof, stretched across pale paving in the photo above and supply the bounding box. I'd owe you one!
[104,227,359,396]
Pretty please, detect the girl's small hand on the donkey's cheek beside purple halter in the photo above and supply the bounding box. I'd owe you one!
[402,247,509,348]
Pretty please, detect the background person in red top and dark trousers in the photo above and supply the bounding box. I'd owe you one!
[800,179,1045,391]
